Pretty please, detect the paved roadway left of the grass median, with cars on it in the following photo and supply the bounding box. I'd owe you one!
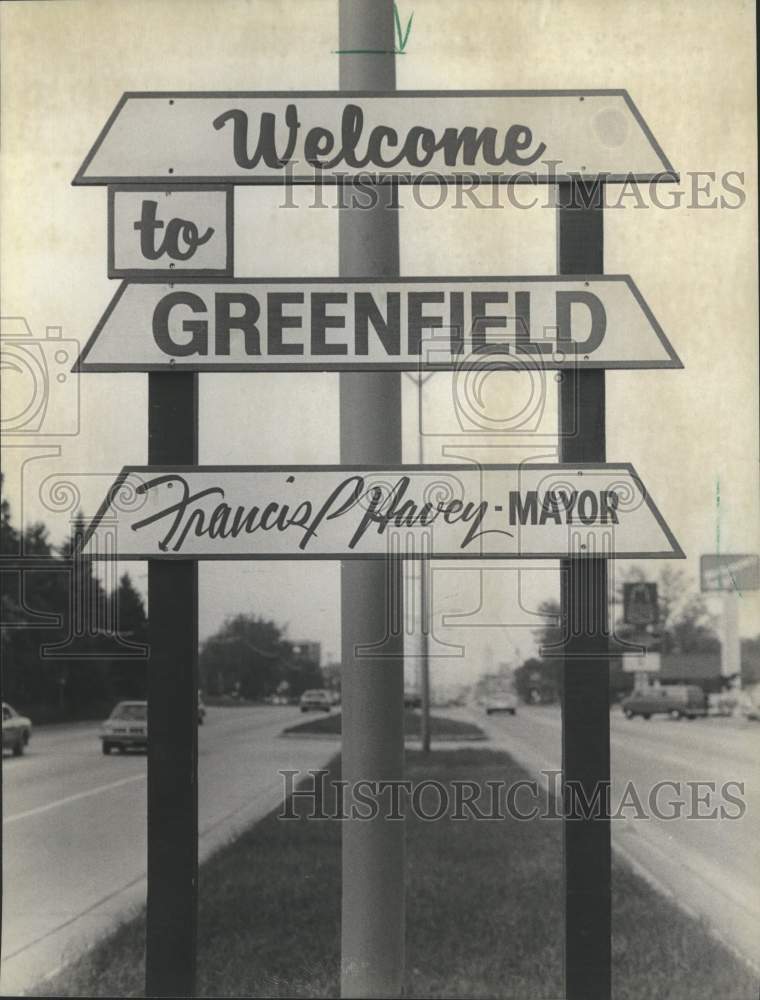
[0,706,336,995]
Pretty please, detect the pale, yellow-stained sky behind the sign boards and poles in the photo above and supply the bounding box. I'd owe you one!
[0,0,760,683]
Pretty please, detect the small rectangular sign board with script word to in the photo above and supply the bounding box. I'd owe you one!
[108,185,233,279]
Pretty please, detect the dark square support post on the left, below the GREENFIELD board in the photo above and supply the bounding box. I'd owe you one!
[145,372,198,997]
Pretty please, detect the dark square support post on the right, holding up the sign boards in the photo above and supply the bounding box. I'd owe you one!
[558,183,612,1000]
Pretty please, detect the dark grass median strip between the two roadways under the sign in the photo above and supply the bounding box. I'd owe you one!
[35,747,758,1000]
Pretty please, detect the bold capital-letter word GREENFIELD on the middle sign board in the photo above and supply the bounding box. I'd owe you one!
[153,282,607,362]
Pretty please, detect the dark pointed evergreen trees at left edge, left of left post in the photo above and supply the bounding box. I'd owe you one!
[0,482,148,722]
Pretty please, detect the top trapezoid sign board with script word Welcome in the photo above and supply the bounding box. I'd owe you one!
[74,90,677,184]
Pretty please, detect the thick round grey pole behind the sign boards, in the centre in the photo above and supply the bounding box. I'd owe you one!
[339,0,404,997]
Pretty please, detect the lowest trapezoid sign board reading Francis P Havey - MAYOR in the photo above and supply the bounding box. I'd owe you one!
[83,464,683,559]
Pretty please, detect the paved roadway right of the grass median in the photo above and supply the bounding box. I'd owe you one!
[477,707,760,970]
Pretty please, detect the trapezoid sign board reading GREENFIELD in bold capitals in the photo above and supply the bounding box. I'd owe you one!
[74,275,683,371]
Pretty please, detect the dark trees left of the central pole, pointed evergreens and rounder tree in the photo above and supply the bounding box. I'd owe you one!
[0,482,323,722]
